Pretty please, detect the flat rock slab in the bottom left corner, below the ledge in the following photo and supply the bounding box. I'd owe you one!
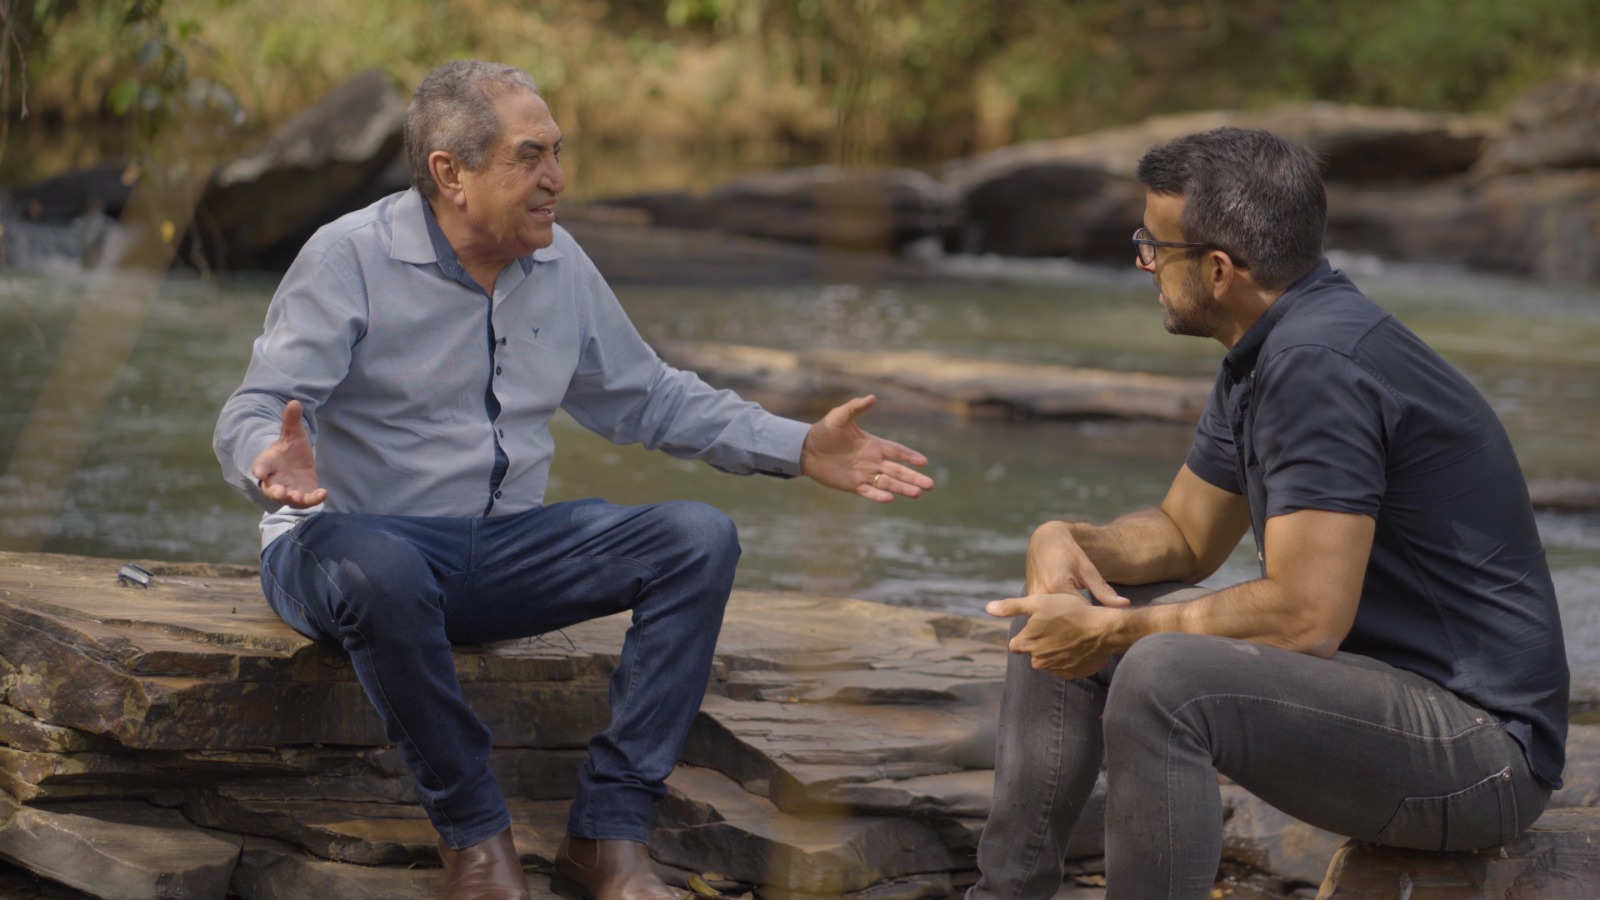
[0,798,242,900]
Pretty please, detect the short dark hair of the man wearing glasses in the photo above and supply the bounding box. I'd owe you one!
[1134,128,1328,288]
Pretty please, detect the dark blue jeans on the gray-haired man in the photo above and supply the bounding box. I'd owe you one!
[261,500,739,849]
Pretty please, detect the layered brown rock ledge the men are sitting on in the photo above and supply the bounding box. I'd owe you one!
[0,554,1600,900]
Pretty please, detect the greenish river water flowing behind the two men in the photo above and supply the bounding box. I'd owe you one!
[0,246,1600,703]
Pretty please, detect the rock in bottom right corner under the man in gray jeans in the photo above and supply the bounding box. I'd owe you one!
[1317,809,1600,900]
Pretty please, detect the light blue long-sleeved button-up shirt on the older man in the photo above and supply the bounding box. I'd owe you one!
[214,191,810,548]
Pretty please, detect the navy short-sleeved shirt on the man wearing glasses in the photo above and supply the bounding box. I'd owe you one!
[1187,261,1568,788]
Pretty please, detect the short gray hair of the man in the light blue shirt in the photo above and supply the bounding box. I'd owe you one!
[405,59,539,197]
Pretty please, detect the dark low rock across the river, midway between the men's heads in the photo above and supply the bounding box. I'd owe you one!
[709,165,950,251]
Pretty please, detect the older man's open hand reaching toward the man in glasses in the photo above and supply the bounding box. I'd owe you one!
[800,396,933,503]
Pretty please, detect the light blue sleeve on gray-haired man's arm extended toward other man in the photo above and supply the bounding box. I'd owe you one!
[562,245,810,477]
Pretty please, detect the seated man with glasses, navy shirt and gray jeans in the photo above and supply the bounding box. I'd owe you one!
[970,128,1568,900]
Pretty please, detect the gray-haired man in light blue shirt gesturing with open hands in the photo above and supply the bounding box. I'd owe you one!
[216,61,933,900]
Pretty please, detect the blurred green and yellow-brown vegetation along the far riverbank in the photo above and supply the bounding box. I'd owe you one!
[0,0,1600,181]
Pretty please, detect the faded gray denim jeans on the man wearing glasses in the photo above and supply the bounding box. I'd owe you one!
[968,585,1549,900]
